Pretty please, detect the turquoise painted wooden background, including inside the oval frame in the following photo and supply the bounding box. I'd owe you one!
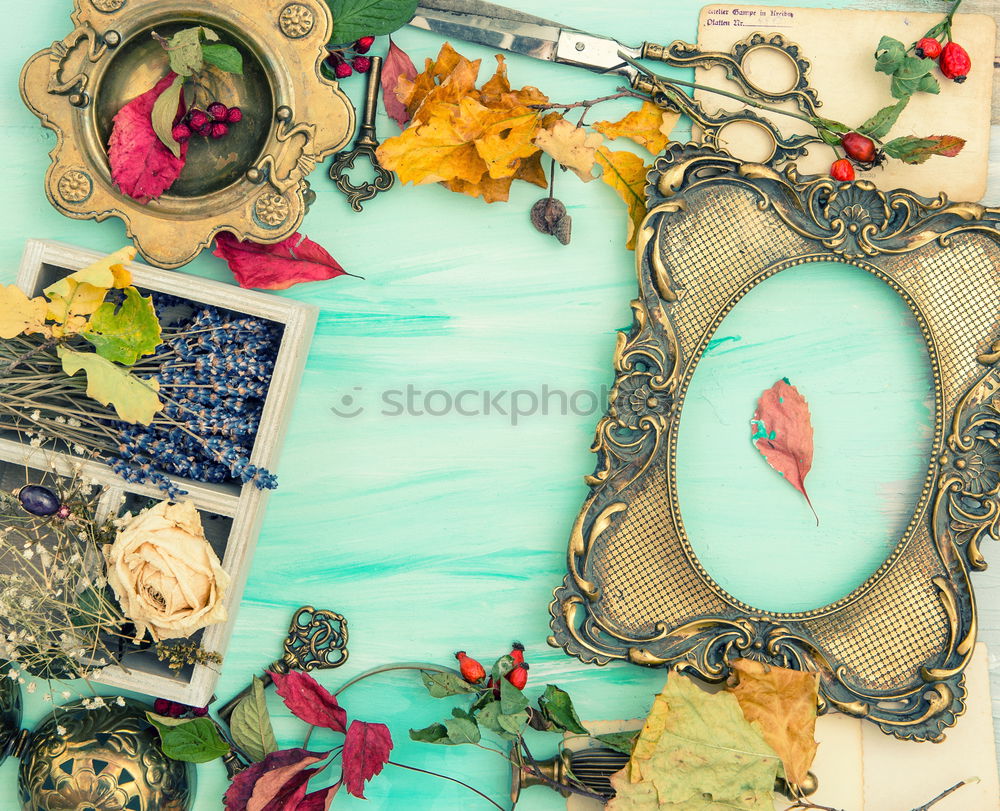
[0,0,1000,811]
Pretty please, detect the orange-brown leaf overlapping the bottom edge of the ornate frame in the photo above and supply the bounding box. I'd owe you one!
[733,659,819,785]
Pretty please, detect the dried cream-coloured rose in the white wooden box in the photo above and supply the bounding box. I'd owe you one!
[104,501,229,641]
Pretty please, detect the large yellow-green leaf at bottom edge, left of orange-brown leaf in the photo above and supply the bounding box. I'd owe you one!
[606,673,779,811]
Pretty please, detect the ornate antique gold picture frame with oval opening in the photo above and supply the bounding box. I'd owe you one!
[549,144,1000,740]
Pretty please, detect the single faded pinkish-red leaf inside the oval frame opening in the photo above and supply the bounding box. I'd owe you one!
[750,378,819,525]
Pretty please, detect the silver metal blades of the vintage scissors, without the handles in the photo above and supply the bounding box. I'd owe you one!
[410,0,639,76]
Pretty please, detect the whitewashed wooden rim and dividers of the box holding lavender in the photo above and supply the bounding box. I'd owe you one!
[0,240,318,707]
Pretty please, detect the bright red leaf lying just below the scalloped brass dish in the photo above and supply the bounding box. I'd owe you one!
[215,231,347,290]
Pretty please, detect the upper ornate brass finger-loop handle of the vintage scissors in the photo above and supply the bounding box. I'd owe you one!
[642,32,823,115]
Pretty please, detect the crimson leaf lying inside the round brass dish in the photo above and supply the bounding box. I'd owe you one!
[108,73,188,203]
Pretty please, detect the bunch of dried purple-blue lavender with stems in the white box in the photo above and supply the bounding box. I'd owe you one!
[0,293,281,498]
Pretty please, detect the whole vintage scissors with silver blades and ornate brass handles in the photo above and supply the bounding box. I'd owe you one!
[410,0,821,163]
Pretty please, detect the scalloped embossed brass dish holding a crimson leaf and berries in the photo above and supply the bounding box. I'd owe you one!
[20,0,354,268]
